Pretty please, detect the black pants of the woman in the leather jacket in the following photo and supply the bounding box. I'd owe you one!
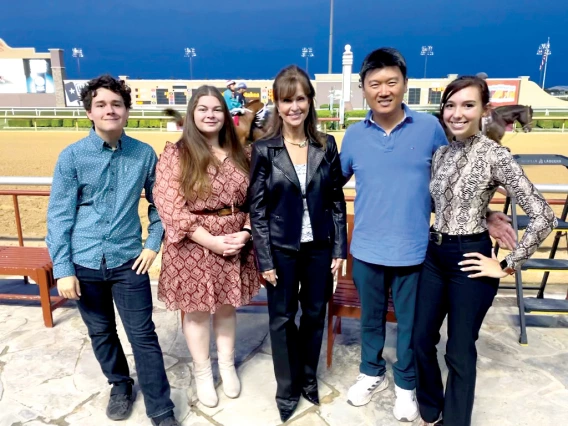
[266,243,333,403]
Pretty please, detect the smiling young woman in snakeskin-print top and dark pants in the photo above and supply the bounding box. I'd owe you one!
[414,77,556,426]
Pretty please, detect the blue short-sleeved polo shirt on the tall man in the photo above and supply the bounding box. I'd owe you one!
[340,104,448,266]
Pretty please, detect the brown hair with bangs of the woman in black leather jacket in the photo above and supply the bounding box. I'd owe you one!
[263,65,327,148]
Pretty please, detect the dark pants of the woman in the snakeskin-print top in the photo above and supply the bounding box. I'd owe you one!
[413,232,499,426]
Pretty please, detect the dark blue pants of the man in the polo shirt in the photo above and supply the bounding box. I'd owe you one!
[353,259,422,390]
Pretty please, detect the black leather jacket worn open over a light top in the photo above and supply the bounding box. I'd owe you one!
[248,135,347,271]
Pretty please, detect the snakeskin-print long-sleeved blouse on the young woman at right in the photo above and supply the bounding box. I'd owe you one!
[430,133,557,269]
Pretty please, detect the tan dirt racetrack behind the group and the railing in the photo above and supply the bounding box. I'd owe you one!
[0,131,568,283]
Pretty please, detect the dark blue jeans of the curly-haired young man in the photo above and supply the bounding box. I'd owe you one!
[75,258,174,418]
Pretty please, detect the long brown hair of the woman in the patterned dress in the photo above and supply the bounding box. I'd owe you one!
[176,85,250,197]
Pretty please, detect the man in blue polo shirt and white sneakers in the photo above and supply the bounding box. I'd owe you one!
[340,48,515,422]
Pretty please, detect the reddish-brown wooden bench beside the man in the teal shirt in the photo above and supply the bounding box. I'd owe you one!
[0,246,67,328]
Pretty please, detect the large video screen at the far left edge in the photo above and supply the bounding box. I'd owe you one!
[0,59,55,93]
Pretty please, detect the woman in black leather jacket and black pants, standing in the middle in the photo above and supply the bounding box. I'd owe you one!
[248,66,347,422]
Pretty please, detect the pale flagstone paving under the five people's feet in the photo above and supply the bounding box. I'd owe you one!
[0,280,568,426]
